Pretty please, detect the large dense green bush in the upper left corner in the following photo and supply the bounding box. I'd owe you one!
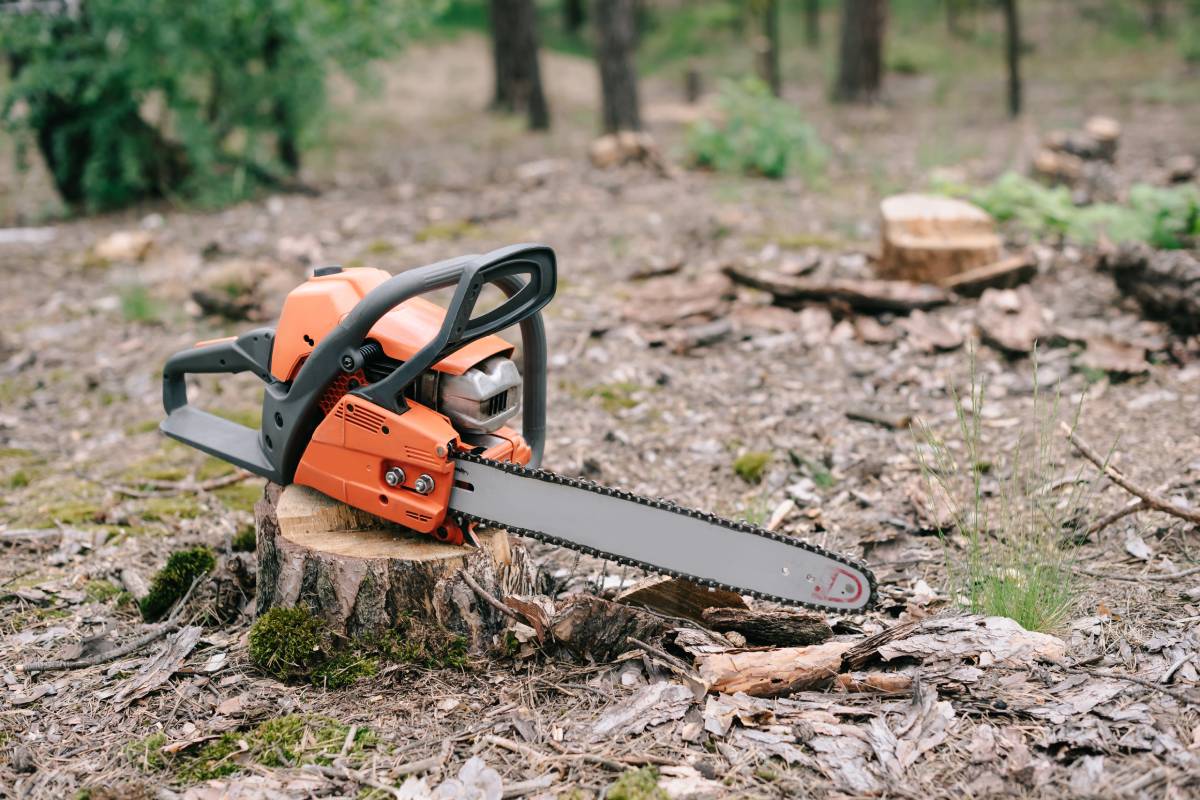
[0,0,436,209]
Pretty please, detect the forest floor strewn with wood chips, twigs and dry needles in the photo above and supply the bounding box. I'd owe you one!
[0,31,1200,798]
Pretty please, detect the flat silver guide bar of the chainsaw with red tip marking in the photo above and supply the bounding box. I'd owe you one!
[450,451,876,614]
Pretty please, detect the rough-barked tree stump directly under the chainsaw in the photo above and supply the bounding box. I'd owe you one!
[254,483,533,652]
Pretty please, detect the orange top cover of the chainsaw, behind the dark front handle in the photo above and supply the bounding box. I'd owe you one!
[271,269,512,380]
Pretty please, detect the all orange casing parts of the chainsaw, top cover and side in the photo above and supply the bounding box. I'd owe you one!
[271,269,530,545]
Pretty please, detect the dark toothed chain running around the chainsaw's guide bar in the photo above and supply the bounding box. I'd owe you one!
[451,451,878,614]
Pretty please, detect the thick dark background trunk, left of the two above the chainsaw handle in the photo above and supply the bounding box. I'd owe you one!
[490,0,550,131]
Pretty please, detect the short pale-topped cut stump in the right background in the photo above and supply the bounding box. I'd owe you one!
[877,194,1001,283]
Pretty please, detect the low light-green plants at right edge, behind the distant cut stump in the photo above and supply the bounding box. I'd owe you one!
[940,173,1200,248]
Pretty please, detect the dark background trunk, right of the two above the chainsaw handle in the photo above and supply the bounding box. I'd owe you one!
[592,0,642,133]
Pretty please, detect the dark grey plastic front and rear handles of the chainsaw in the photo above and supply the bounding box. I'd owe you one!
[161,245,557,483]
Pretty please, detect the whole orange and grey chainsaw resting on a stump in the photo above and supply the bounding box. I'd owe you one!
[161,245,875,612]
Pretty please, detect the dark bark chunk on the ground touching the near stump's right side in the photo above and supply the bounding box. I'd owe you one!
[550,595,668,663]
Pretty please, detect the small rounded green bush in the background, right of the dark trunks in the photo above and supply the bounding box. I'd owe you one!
[688,80,827,178]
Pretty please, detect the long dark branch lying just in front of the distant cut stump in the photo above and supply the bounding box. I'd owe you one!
[725,266,950,313]
